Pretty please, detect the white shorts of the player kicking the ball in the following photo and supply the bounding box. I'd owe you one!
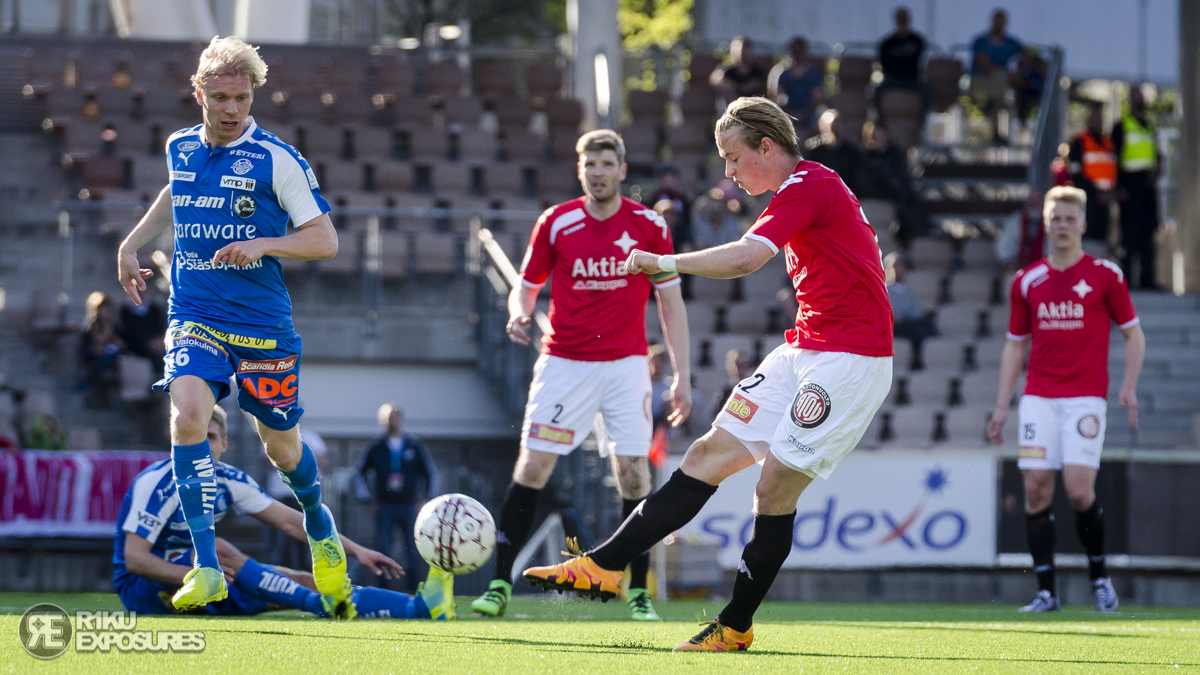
[713,344,892,478]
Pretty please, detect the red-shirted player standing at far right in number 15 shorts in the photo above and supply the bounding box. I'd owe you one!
[988,187,1146,611]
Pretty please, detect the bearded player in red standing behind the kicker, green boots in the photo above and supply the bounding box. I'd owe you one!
[470,130,691,621]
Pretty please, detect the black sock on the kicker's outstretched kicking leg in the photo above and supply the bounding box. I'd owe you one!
[588,470,716,572]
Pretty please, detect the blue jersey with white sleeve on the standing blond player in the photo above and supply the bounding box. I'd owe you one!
[167,118,329,338]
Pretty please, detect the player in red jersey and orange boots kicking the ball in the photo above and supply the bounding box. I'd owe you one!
[524,97,892,651]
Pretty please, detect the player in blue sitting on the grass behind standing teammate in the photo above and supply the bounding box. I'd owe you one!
[113,407,455,620]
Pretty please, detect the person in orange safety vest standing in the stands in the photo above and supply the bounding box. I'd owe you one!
[1067,103,1117,257]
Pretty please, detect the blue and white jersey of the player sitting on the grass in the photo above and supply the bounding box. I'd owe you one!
[113,459,275,578]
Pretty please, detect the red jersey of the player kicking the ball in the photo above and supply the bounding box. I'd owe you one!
[746,160,893,357]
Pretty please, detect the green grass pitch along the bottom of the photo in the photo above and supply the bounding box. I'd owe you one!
[0,593,1200,675]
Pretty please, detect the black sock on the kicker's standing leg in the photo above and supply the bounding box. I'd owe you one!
[716,512,796,633]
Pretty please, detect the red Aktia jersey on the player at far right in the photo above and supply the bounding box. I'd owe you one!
[1008,253,1138,399]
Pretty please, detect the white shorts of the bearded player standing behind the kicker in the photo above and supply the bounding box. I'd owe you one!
[521,354,654,458]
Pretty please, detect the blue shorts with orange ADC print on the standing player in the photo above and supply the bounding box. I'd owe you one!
[155,318,304,431]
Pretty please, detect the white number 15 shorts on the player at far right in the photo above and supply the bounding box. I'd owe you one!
[1016,395,1109,470]
